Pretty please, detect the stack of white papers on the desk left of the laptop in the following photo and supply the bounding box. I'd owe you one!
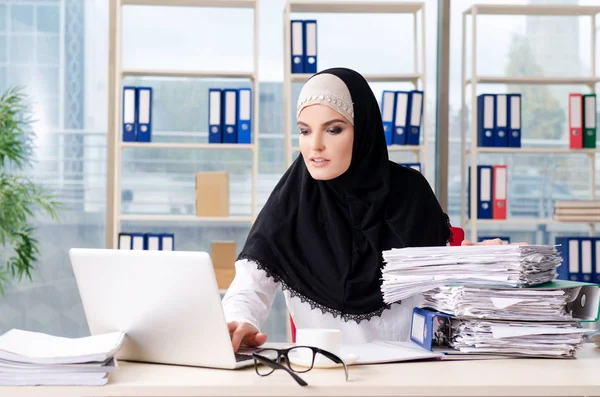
[0,329,124,386]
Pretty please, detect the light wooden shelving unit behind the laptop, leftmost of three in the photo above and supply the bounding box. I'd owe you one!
[106,0,259,248]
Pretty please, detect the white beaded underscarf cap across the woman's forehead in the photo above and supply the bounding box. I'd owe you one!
[296,73,354,125]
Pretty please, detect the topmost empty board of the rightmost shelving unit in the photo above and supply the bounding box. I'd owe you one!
[463,4,600,16]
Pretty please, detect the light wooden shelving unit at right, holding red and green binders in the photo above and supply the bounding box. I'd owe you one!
[461,4,600,241]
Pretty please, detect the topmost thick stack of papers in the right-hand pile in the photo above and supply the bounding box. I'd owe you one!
[381,245,562,304]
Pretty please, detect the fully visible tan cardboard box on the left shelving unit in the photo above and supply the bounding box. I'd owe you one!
[196,171,229,217]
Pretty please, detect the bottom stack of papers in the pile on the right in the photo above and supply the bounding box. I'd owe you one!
[449,318,589,358]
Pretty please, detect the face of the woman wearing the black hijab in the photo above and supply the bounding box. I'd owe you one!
[298,105,354,180]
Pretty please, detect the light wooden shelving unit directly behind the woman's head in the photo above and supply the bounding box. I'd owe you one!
[283,0,428,174]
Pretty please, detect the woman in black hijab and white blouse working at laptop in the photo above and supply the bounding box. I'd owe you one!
[223,68,450,349]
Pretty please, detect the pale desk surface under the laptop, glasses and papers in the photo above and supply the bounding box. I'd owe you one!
[0,344,600,397]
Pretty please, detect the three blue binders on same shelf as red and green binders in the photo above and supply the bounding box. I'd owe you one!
[477,94,521,147]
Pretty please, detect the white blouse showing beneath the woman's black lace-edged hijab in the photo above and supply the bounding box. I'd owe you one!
[222,259,422,343]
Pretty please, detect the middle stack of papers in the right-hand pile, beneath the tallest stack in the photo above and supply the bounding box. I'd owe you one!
[422,286,579,321]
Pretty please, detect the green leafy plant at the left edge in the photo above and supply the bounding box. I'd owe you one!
[0,87,62,295]
